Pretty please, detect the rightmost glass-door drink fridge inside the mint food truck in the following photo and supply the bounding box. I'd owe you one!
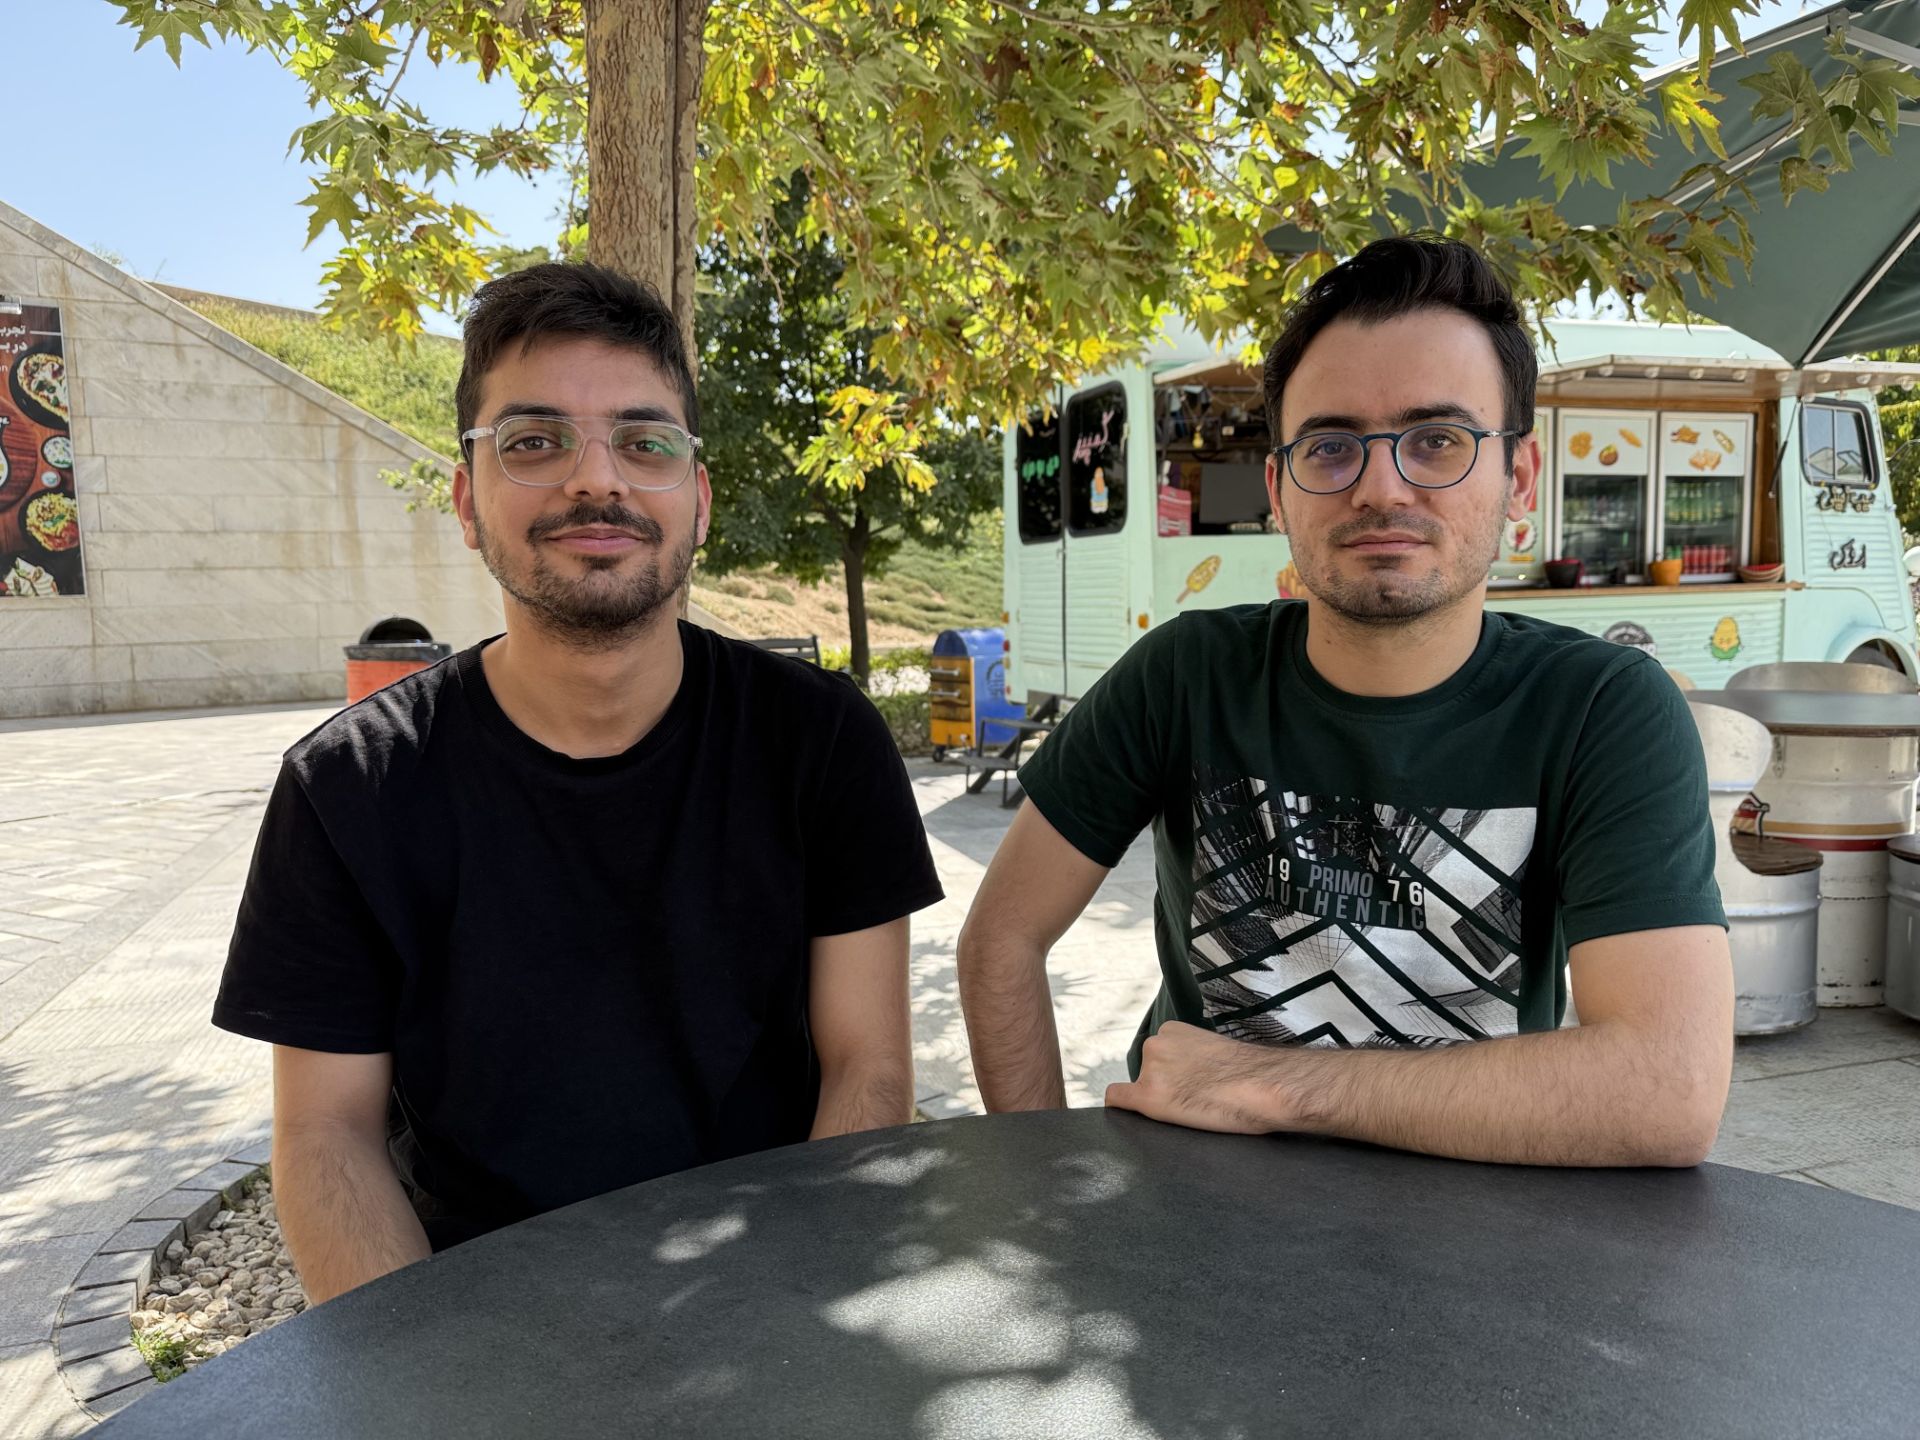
[1653,411,1753,584]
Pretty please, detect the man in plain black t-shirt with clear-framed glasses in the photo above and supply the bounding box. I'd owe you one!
[213,265,941,1300]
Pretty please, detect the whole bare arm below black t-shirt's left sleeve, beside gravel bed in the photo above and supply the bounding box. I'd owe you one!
[273,1044,430,1304]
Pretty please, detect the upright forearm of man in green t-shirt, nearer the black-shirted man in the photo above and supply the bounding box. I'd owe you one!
[958,927,1068,1112]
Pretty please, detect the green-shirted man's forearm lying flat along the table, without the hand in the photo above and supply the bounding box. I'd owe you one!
[1235,1025,1728,1165]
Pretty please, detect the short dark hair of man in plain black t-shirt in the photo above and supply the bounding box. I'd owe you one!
[453,263,701,457]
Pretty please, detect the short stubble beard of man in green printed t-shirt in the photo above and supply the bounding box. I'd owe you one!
[1288,482,1511,626]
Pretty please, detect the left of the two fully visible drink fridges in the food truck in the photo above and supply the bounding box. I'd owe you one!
[1553,411,1653,586]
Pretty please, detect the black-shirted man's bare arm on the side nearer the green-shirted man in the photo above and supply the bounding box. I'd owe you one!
[806,916,914,1140]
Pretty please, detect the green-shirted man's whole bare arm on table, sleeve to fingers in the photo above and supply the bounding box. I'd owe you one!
[1108,925,1734,1165]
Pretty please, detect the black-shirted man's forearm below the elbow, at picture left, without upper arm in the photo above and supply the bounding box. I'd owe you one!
[273,1125,430,1304]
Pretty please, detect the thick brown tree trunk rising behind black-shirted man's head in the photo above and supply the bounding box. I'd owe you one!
[586,0,707,365]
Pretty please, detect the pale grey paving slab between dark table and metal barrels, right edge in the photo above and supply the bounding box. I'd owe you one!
[1709,1060,1920,1173]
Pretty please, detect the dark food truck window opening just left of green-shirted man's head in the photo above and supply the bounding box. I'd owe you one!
[1154,386,1273,536]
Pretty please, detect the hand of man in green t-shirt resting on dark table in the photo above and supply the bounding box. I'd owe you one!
[1106,1020,1284,1135]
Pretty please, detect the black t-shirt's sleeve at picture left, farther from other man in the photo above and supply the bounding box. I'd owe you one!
[213,764,399,1054]
